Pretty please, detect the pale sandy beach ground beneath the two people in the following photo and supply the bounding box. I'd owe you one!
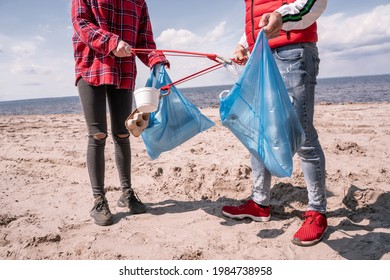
[0,103,390,260]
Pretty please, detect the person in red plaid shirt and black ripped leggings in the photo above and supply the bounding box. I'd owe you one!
[71,0,168,226]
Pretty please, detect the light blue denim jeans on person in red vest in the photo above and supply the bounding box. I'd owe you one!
[251,43,326,213]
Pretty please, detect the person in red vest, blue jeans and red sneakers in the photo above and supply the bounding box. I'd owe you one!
[222,0,328,246]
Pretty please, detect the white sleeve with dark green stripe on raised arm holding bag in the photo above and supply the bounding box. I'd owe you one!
[276,0,328,31]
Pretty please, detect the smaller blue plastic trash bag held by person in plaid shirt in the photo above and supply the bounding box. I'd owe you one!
[141,64,215,159]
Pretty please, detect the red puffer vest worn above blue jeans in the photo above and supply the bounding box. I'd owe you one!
[245,0,318,51]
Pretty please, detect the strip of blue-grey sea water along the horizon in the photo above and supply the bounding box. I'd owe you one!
[0,74,390,115]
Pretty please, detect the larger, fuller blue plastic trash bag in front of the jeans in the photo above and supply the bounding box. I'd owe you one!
[220,31,305,177]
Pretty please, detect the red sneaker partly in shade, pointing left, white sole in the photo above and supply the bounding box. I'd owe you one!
[222,199,271,222]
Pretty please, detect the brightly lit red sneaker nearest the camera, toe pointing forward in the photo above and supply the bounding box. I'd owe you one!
[292,211,328,246]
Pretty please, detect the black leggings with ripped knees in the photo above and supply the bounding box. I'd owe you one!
[77,79,132,197]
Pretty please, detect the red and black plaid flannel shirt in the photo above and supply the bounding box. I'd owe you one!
[72,0,168,89]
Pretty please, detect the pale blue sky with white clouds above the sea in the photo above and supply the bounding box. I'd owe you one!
[0,0,390,101]
